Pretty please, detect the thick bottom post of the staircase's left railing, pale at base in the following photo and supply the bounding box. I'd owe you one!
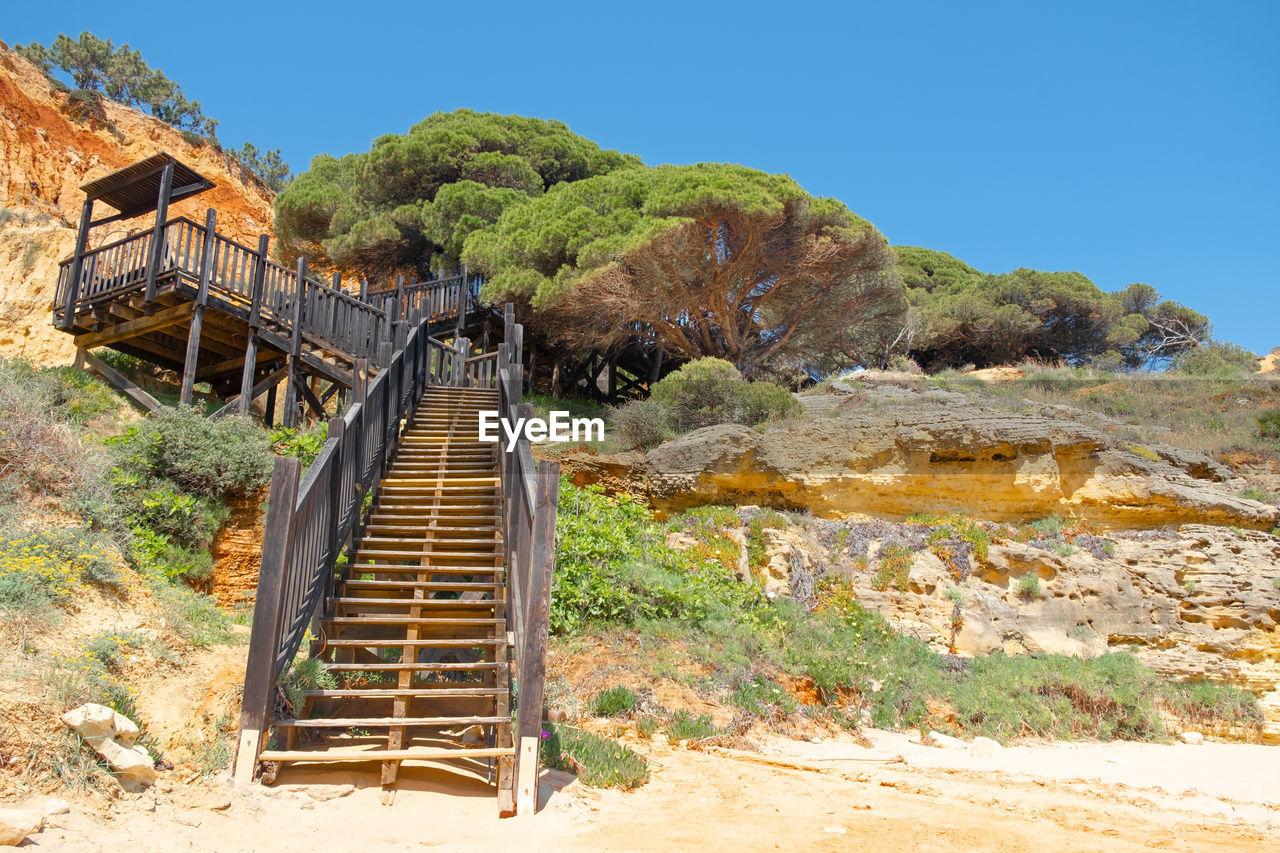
[236,456,300,784]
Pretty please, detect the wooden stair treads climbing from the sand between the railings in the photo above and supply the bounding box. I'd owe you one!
[260,387,515,802]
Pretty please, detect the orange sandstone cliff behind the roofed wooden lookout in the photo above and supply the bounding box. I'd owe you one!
[0,42,273,364]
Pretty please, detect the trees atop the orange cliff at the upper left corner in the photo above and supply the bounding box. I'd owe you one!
[14,31,218,140]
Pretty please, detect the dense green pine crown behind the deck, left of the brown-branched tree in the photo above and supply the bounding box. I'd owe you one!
[275,110,639,277]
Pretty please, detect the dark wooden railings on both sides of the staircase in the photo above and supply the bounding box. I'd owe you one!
[236,305,559,813]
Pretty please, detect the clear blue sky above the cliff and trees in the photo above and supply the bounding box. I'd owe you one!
[10,0,1280,352]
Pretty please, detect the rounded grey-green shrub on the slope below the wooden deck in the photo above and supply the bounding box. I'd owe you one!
[113,406,271,498]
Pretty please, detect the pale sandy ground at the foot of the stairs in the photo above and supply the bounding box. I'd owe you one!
[12,733,1280,853]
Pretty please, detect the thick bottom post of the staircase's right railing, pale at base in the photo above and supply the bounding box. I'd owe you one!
[516,461,559,815]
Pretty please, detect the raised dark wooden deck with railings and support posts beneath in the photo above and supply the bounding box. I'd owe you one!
[54,210,489,427]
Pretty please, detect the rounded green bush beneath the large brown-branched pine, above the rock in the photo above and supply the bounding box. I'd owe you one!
[650,359,803,433]
